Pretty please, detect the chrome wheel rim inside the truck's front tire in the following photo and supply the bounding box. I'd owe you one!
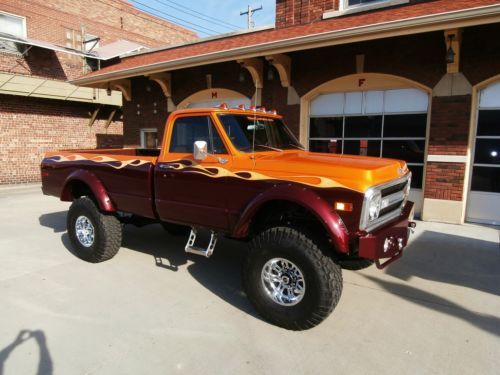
[261,258,306,306]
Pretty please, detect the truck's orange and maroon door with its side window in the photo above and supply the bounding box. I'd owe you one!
[155,114,232,230]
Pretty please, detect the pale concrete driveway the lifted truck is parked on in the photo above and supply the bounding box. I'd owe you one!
[0,187,500,375]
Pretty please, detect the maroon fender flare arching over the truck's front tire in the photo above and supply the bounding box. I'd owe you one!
[232,184,349,253]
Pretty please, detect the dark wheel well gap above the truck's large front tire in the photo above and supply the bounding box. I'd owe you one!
[250,200,333,251]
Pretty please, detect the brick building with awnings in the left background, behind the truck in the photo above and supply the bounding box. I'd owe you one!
[0,0,196,184]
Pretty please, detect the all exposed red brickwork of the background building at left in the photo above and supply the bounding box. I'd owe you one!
[0,0,196,184]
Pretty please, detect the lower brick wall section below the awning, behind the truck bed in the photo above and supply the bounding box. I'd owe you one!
[0,95,123,184]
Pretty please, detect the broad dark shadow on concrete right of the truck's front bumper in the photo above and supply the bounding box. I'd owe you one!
[385,230,500,296]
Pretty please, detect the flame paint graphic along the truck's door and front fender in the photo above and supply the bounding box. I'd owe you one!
[164,160,352,190]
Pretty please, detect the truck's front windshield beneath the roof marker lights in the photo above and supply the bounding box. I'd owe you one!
[218,114,304,152]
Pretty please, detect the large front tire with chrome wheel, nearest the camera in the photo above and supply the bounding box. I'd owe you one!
[243,227,342,330]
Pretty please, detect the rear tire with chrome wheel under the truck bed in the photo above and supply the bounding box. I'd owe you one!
[66,197,122,263]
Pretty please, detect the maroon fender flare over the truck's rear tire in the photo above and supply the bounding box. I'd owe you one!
[61,169,116,212]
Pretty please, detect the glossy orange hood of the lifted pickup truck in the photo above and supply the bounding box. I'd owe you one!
[255,151,408,193]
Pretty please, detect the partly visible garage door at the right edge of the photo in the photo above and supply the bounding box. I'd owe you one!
[467,82,500,225]
